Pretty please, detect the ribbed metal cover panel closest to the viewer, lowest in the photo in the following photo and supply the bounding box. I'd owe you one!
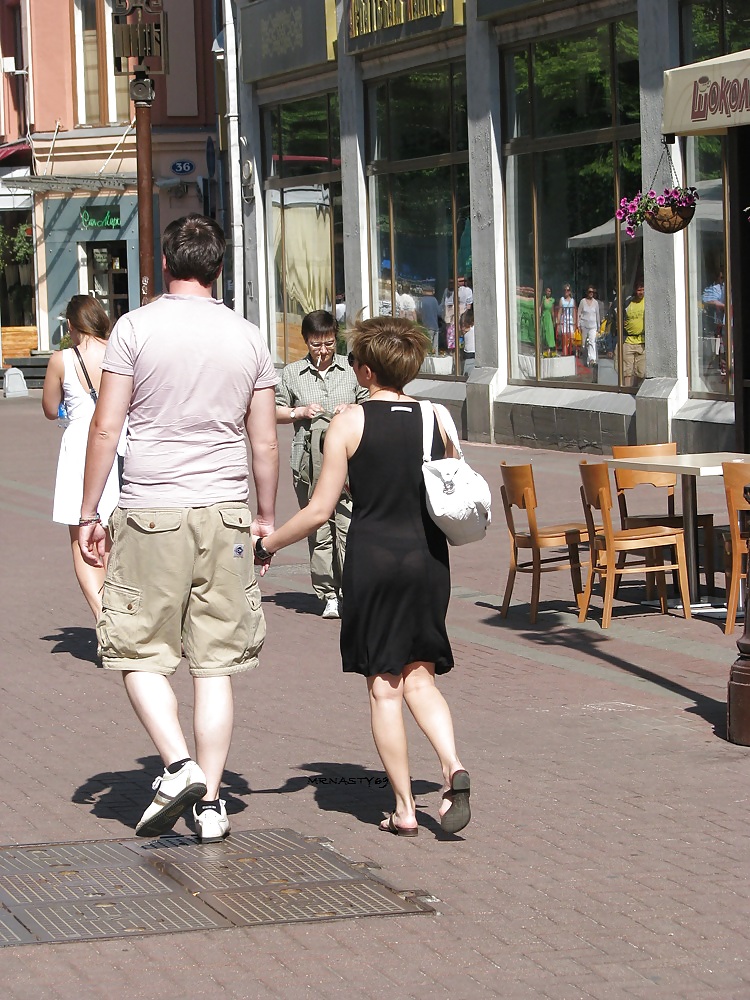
[14,895,230,941]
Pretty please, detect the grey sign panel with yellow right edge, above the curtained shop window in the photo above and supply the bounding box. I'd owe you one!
[239,0,336,83]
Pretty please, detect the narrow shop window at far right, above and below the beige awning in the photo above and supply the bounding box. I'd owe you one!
[681,0,750,399]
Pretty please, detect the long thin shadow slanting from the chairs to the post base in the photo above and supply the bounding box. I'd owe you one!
[477,602,729,740]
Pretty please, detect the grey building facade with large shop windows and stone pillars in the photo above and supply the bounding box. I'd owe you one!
[230,0,750,451]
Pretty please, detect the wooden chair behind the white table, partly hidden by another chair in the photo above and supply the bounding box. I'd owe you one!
[612,441,715,594]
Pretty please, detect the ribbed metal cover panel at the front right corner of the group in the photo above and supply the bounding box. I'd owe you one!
[201,881,424,924]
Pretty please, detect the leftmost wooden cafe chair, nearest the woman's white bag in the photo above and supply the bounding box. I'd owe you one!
[500,462,588,625]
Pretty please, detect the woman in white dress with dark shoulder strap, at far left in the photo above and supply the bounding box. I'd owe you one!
[42,295,120,620]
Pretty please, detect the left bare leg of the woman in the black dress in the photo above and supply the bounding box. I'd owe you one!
[367,674,417,828]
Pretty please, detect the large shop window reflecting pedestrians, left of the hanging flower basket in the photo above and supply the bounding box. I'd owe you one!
[503,16,647,388]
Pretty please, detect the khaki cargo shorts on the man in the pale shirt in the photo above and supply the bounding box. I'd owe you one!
[96,501,266,677]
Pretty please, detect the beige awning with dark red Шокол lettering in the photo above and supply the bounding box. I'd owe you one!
[661,49,750,135]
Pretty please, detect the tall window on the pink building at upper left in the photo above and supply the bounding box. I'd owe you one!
[73,0,130,125]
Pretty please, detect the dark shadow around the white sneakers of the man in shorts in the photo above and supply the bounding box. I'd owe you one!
[72,755,250,831]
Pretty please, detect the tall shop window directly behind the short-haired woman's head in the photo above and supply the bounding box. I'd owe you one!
[368,65,474,377]
